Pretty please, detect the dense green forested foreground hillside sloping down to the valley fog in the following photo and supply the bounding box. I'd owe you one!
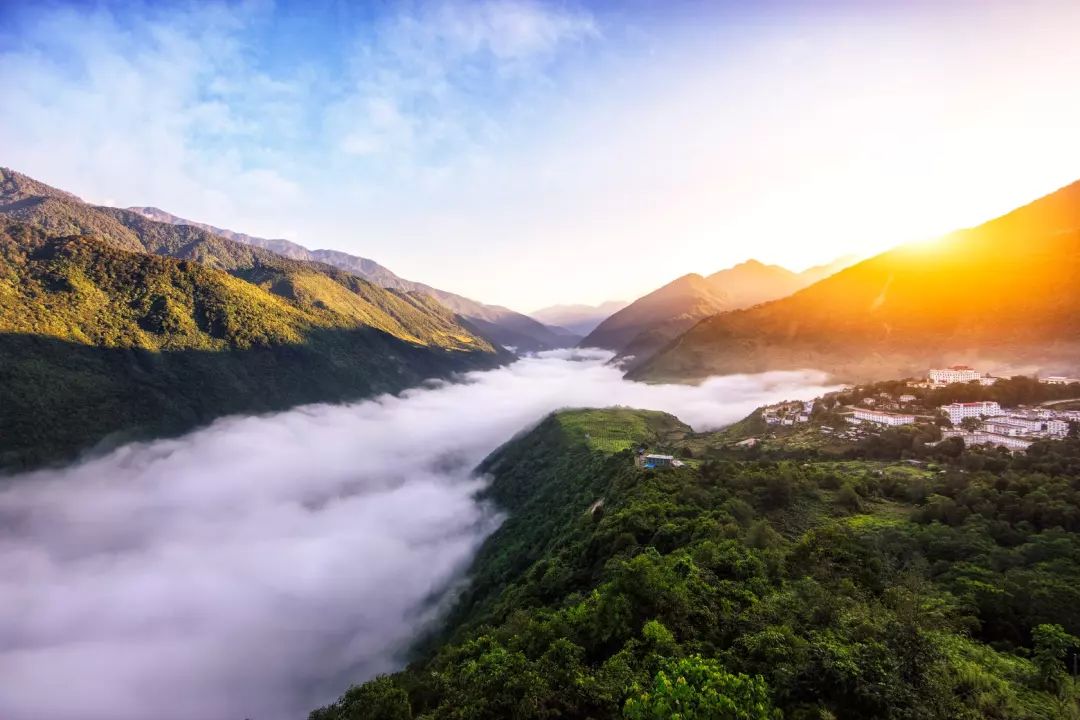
[312,410,1080,720]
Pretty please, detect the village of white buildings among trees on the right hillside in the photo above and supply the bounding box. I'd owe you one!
[740,365,1080,451]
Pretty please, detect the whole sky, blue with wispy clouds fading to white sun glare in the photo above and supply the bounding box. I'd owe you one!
[0,0,1080,311]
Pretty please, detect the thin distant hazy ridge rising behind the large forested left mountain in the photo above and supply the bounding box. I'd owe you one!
[127,207,583,352]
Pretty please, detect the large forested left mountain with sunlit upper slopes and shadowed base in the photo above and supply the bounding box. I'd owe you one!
[0,169,511,470]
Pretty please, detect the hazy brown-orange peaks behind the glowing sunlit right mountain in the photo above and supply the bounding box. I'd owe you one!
[581,259,850,361]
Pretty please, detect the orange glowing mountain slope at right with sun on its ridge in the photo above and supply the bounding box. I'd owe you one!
[630,182,1080,381]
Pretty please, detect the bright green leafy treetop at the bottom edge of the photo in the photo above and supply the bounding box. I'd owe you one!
[623,655,774,720]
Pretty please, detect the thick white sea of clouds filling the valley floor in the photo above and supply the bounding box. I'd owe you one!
[0,351,828,720]
